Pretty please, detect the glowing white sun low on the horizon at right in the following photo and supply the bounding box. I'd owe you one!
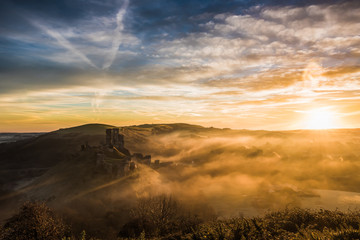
[306,108,336,129]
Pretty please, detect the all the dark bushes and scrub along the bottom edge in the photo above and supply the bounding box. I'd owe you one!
[0,195,360,240]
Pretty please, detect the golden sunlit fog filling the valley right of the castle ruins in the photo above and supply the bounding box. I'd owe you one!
[127,130,360,216]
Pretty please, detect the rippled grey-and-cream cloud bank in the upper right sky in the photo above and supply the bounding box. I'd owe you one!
[147,0,360,90]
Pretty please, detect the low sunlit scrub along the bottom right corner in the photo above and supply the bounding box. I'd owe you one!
[182,208,360,240]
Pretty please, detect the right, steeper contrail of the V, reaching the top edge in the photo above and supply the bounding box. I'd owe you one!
[102,0,129,69]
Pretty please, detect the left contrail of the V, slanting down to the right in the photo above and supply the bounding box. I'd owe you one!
[30,20,98,69]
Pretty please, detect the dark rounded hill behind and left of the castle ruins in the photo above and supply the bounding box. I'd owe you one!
[0,124,116,199]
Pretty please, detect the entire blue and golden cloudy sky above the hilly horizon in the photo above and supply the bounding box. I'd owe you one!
[0,0,360,132]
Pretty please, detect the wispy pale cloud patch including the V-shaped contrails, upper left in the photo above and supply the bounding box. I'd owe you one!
[28,0,132,70]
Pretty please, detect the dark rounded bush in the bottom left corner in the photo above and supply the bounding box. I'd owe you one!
[0,202,68,240]
